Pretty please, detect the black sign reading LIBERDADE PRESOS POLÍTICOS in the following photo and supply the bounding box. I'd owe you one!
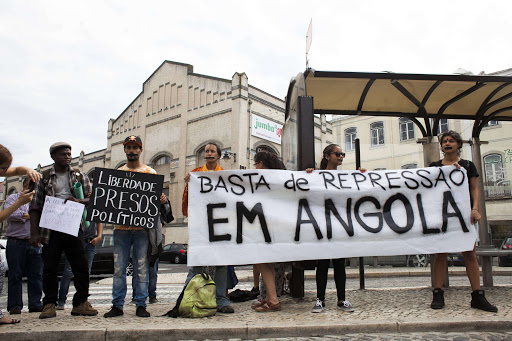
[87,168,164,228]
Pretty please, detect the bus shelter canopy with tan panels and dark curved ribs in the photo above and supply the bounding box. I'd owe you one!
[302,69,512,137]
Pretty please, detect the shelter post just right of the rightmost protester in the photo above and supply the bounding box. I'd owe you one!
[471,137,493,288]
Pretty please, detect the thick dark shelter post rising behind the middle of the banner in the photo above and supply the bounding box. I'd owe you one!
[290,96,315,298]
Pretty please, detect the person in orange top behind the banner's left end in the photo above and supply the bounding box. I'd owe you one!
[181,142,235,314]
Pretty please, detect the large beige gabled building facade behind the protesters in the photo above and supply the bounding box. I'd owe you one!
[1,61,332,243]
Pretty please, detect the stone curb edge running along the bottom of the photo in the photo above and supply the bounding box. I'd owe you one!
[2,319,512,341]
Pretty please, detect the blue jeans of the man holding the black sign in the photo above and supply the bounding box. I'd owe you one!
[112,230,149,309]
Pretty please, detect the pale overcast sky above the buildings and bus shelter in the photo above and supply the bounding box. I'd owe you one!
[0,0,512,171]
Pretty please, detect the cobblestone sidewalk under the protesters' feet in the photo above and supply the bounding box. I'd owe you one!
[0,273,512,341]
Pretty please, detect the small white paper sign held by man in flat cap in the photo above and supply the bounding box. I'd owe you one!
[39,195,85,237]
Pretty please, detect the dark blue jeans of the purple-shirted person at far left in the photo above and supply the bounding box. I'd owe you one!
[6,238,43,311]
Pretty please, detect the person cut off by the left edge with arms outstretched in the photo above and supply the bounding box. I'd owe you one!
[0,144,36,325]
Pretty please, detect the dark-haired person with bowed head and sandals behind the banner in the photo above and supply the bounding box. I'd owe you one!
[252,151,284,313]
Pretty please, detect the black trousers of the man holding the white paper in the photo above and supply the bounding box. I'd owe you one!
[42,231,89,307]
